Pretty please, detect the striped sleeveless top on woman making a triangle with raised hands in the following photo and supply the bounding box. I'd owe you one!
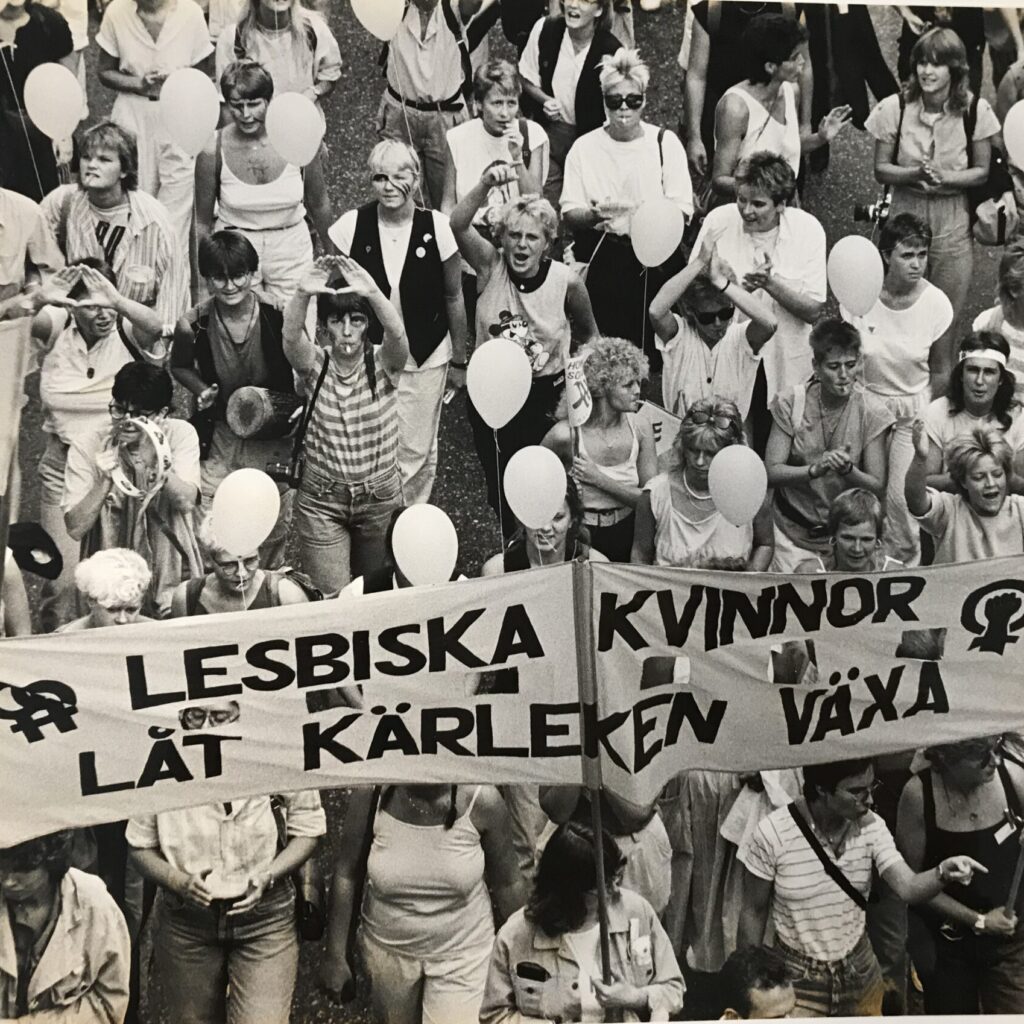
[305,347,398,483]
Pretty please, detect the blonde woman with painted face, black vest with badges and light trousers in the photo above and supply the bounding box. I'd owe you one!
[329,139,469,505]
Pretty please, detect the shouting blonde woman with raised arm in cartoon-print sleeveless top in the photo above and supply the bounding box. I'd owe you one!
[452,164,597,537]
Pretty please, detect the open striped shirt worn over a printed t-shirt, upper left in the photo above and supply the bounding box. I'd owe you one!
[40,185,188,326]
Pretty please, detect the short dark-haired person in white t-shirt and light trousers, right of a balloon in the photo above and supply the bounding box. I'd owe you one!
[841,213,953,565]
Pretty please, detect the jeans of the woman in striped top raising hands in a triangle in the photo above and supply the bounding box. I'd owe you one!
[295,465,403,597]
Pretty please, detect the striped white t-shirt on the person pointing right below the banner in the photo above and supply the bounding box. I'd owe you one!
[738,807,904,962]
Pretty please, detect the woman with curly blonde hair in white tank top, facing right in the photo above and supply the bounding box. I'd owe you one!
[544,338,657,562]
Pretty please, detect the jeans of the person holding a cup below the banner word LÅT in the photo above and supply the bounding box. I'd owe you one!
[154,879,299,1024]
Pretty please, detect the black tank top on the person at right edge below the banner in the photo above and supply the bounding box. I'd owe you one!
[918,764,1024,941]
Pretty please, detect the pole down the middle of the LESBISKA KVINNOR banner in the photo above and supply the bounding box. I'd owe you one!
[572,557,614,995]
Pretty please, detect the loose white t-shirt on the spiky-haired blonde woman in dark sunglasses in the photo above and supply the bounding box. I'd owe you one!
[560,122,693,234]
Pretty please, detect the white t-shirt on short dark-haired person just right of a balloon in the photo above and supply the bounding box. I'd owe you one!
[841,281,953,397]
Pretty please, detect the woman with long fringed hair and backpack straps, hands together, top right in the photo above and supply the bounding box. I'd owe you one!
[864,29,999,335]
